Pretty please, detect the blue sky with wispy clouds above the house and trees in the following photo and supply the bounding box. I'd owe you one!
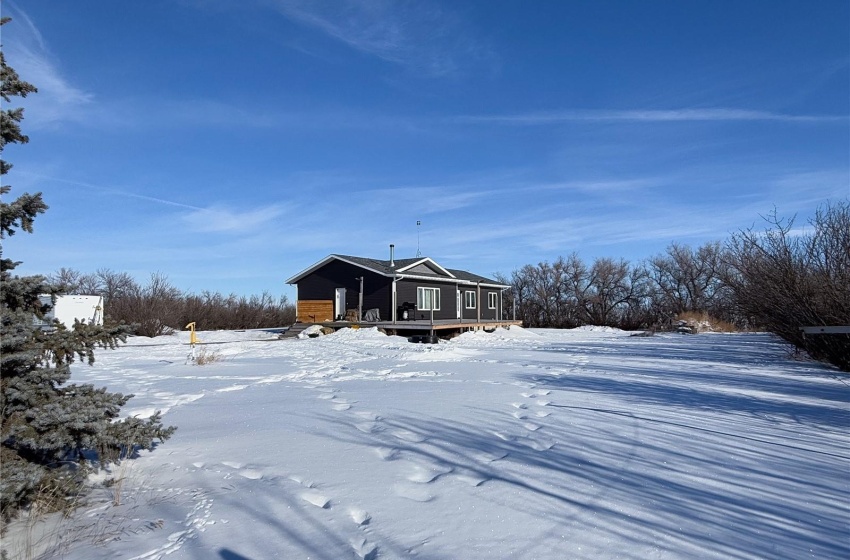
[2,0,850,297]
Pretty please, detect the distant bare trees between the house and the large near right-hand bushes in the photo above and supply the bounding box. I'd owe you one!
[502,242,738,329]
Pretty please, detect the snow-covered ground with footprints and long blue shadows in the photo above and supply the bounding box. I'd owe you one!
[8,328,850,560]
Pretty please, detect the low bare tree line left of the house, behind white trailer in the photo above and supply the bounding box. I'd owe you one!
[49,268,295,337]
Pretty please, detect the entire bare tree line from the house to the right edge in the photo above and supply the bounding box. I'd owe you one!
[499,201,850,370]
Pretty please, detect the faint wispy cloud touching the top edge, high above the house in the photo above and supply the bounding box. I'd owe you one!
[274,0,486,75]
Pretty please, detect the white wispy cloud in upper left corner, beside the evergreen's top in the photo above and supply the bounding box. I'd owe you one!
[3,0,94,128]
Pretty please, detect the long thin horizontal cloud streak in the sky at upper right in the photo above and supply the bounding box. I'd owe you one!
[447,108,850,126]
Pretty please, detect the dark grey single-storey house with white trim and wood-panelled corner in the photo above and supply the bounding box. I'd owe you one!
[286,250,510,323]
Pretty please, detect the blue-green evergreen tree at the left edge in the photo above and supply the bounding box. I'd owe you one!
[0,18,175,519]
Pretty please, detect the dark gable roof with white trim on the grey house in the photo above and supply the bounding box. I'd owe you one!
[286,255,510,288]
